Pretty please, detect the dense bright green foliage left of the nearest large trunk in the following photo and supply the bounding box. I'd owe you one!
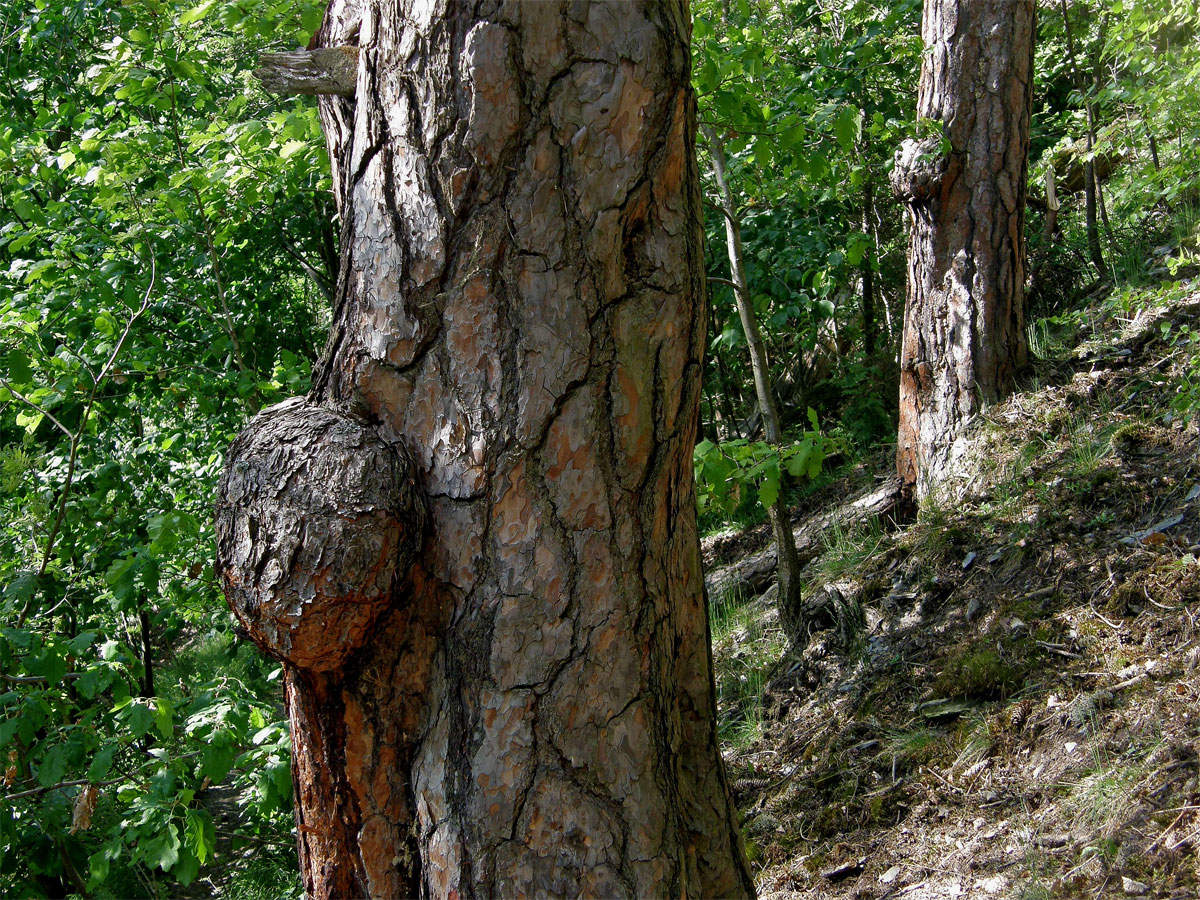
[0,0,336,896]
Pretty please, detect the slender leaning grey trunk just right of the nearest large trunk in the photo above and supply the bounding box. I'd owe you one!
[704,127,804,637]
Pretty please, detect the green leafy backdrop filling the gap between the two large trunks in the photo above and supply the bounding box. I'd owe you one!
[692,0,920,440]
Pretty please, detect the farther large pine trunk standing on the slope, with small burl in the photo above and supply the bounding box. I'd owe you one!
[892,0,1034,499]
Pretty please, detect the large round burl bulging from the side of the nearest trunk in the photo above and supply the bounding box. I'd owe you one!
[216,398,425,672]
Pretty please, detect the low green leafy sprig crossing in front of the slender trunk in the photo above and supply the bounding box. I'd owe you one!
[692,409,838,516]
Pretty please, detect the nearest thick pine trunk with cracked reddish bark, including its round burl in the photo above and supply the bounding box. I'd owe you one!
[218,0,752,898]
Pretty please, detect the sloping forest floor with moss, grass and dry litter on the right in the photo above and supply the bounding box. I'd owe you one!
[704,281,1200,900]
